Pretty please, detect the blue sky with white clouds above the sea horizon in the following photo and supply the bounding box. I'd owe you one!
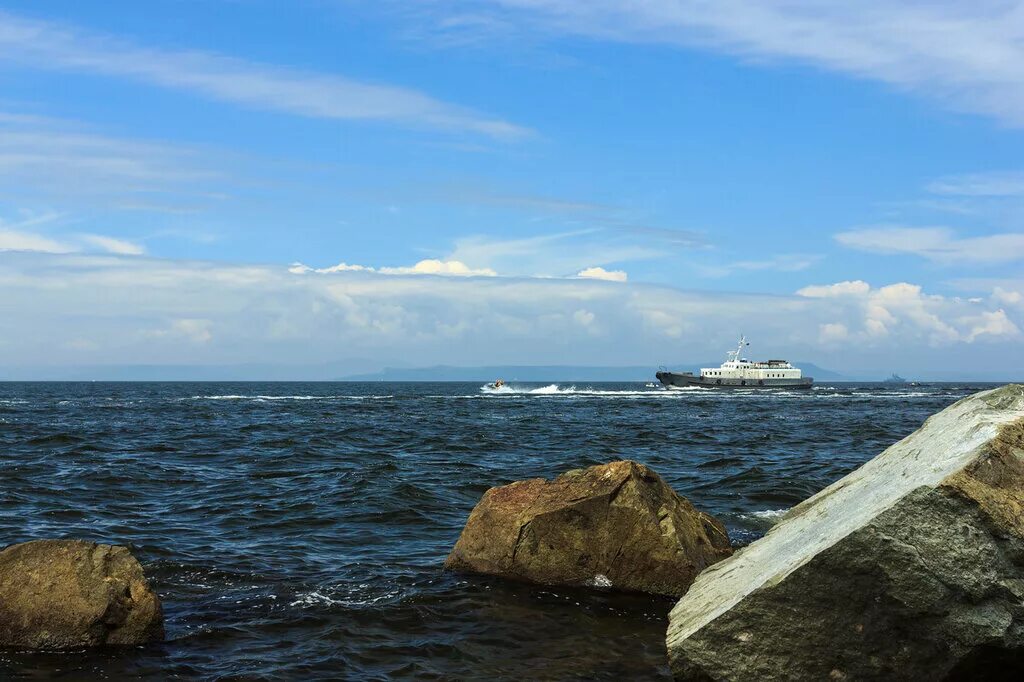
[0,0,1024,379]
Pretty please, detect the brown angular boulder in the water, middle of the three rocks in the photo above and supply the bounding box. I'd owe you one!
[444,461,732,596]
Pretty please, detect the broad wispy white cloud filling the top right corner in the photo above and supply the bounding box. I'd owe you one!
[437,0,1024,126]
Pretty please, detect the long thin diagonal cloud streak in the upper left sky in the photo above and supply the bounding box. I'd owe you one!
[0,13,527,138]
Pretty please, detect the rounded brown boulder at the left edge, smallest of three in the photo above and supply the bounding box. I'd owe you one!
[0,540,164,649]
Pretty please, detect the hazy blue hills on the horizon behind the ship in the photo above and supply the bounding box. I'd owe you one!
[341,361,853,381]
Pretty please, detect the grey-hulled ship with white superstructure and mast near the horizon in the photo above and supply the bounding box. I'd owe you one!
[654,336,814,389]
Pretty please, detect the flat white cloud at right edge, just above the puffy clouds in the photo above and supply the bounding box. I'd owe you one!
[836,225,1024,264]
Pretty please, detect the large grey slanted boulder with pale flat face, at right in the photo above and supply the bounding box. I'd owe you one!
[668,385,1024,680]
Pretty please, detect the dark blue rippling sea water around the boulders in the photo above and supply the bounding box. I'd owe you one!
[0,383,985,680]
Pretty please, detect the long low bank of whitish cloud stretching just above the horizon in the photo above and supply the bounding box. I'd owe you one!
[0,252,1024,371]
